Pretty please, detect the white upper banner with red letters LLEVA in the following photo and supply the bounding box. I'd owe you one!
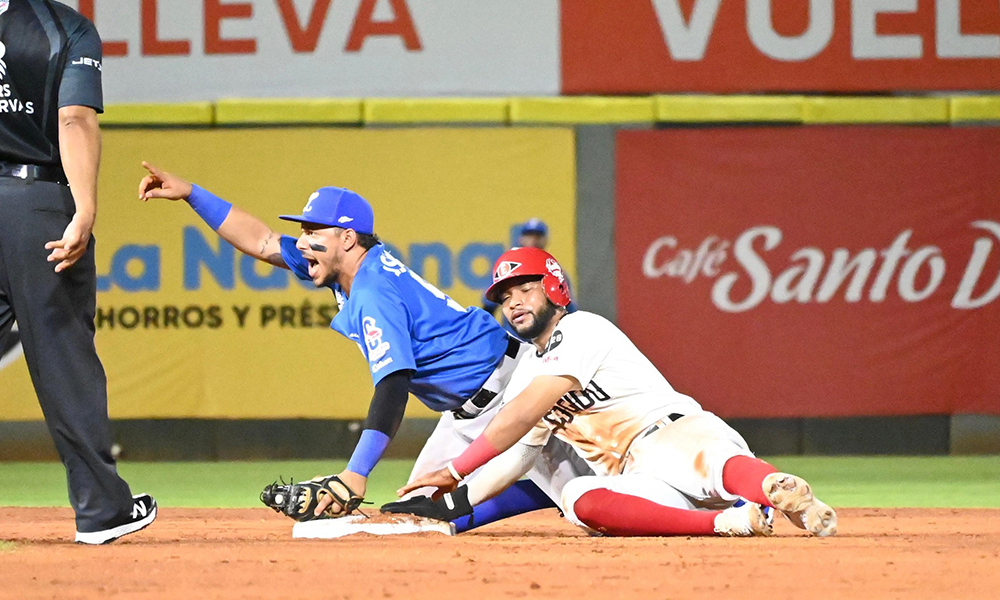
[66,0,559,103]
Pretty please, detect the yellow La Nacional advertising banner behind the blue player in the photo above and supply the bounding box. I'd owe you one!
[0,128,576,420]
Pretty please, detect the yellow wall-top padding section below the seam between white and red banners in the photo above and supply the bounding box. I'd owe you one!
[510,96,655,123]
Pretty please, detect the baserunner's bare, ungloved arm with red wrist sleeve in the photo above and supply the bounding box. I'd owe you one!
[397,375,580,497]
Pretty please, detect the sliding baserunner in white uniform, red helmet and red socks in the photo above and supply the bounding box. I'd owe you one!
[396,248,837,536]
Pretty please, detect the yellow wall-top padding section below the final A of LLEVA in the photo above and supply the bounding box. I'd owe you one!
[364,98,509,124]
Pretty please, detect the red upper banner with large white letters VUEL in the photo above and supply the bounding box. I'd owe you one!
[562,0,1000,94]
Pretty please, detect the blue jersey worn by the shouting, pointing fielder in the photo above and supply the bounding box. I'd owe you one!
[281,236,508,412]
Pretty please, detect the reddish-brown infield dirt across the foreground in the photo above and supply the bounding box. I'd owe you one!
[0,508,1000,600]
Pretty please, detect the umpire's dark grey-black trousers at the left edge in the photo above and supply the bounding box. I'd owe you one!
[0,177,132,532]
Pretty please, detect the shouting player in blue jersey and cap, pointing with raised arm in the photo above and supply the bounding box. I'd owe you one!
[139,162,589,530]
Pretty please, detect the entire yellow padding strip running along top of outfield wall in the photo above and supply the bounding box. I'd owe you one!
[101,94,1000,126]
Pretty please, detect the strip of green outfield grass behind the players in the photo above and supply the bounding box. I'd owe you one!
[0,456,1000,508]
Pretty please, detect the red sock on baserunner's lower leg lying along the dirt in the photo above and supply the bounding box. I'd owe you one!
[573,488,719,536]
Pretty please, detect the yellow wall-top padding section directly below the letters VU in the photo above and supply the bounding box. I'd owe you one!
[656,95,803,123]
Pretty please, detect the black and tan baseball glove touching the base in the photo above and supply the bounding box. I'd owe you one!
[260,475,364,521]
